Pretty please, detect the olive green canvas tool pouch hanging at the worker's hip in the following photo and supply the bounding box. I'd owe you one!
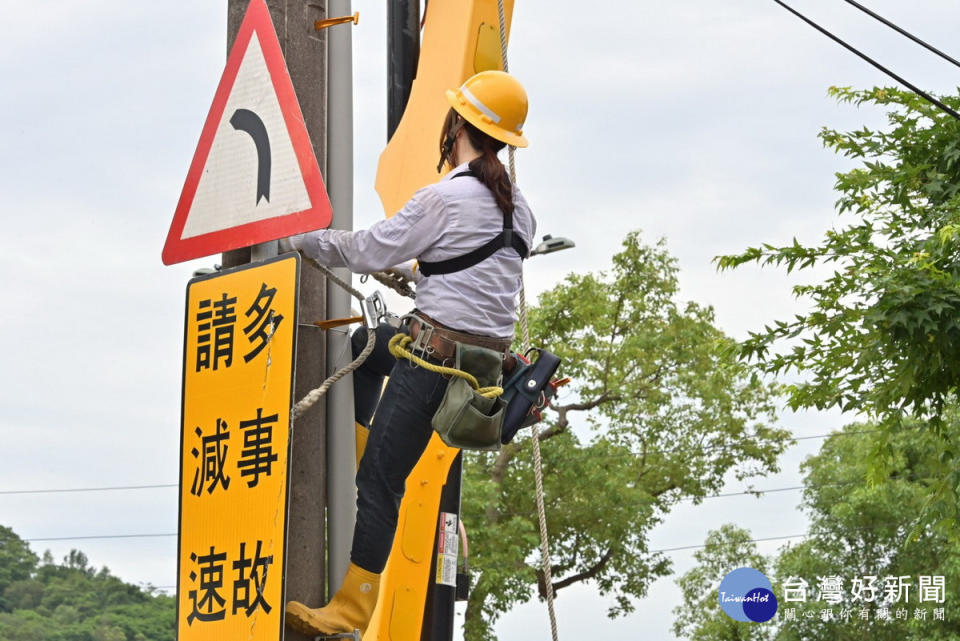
[432,343,506,451]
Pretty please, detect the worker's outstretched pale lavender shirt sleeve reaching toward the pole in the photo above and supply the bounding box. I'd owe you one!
[299,187,448,274]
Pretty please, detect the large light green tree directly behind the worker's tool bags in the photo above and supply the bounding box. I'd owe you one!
[463,233,788,641]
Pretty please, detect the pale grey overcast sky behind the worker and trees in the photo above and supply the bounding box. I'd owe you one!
[0,0,960,641]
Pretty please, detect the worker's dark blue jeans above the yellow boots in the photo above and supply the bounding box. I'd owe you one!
[350,325,447,574]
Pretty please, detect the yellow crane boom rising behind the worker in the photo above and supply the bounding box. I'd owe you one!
[364,0,513,641]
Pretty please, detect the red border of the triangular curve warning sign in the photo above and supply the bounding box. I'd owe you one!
[162,0,333,265]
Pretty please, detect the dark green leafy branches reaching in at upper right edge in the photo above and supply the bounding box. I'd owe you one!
[717,88,960,527]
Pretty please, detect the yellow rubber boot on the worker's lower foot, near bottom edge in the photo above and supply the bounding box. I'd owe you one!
[286,563,380,636]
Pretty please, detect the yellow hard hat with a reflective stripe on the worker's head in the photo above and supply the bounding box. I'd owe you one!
[447,71,527,147]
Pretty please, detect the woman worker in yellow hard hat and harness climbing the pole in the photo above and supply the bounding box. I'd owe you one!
[286,71,536,635]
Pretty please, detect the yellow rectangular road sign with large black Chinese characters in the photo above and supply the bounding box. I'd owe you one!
[177,254,300,641]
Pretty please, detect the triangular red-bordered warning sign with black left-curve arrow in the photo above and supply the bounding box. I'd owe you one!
[163,0,331,265]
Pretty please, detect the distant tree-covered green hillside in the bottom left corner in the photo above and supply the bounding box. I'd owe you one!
[0,527,175,641]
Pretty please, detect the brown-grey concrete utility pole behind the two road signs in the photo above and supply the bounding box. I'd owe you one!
[222,0,330,641]
